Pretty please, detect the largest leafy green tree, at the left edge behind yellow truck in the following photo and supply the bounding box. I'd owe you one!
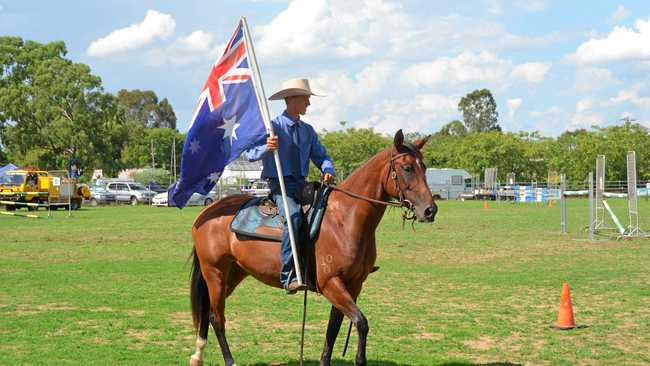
[0,37,128,177]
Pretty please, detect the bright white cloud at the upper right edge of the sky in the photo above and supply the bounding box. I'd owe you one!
[572,18,650,63]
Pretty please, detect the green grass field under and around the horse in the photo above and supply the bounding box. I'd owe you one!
[0,199,650,366]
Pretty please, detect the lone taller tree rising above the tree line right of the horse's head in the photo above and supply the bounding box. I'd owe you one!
[458,89,501,132]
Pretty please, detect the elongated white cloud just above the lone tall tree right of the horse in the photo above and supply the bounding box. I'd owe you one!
[401,52,512,86]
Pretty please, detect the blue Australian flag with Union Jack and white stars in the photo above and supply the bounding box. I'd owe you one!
[168,21,266,208]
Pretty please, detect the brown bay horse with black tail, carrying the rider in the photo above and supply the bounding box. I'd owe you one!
[190,130,438,366]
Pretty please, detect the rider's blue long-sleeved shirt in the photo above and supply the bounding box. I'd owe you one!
[244,111,335,178]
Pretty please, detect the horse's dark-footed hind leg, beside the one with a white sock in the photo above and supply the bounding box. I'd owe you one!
[201,263,235,366]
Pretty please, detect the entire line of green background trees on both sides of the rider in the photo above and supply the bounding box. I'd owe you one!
[0,37,650,183]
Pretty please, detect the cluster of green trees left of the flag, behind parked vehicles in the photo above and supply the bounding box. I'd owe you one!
[0,37,184,178]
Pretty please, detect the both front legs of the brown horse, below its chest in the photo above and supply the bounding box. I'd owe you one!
[321,277,369,366]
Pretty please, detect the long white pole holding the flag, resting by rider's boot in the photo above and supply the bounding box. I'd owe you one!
[241,17,303,286]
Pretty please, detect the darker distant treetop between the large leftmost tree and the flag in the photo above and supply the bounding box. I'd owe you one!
[117,89,176,129]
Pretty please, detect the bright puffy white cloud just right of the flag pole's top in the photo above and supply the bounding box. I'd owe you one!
[255,0,410,62]
